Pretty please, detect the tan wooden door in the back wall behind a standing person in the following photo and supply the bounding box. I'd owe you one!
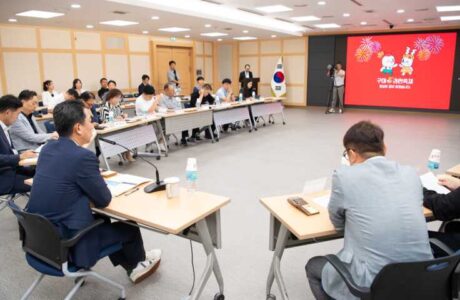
[155,46,193,95]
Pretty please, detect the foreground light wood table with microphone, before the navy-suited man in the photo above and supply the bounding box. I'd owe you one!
[24,177,230,300]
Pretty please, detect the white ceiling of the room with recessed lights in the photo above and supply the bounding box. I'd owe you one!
[0,0,460,40]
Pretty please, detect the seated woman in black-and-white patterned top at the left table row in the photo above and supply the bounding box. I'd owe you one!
[101,89,136,161]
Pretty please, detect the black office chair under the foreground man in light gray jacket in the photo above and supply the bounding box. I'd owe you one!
[323,241,460,300]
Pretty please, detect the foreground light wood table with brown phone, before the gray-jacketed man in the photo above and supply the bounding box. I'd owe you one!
[260,190,434,300]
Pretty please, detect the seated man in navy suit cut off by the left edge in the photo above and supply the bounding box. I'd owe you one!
[0,95,37,195]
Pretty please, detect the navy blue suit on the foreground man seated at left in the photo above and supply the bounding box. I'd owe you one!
[27,137,145,270]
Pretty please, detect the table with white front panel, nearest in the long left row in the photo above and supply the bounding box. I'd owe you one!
[95,115,167,170]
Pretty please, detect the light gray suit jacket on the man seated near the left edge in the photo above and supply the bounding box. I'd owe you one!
[9,113,51,150]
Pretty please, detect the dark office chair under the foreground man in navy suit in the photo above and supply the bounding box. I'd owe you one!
[8,201,126,300]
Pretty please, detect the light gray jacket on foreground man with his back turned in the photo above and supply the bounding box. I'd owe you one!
[322,156,433,299]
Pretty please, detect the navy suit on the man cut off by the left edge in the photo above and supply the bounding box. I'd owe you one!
[0,126,33,195]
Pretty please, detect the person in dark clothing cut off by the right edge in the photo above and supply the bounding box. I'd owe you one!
[423,175,460,257]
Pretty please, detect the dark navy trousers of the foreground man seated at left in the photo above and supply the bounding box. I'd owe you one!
[72,219,145,271]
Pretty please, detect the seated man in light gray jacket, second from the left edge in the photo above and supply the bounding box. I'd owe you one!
[9,90,59,151]
